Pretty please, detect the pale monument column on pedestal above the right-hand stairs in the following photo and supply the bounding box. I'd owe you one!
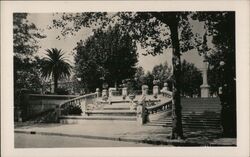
[200,60,210,98]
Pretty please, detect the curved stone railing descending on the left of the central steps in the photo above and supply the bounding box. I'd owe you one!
[57,93,97,117]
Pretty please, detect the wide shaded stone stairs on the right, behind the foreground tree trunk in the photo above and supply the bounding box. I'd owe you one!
[146,98,221,133]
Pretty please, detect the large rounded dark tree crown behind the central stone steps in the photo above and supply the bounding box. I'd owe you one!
[75,25,138,91]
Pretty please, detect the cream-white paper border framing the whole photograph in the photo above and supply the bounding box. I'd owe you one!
[1,0,250,157]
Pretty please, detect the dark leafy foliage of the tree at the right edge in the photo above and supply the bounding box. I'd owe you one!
[193,12,236,92]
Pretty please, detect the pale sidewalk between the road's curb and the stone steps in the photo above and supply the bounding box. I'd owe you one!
[14,120,236,147]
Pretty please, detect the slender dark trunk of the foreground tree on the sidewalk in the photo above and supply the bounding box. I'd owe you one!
[168,16,183,139]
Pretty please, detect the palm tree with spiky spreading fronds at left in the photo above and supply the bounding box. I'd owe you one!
[41,48,72,91]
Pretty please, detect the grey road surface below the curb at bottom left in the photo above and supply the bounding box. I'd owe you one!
[14,133,156,148]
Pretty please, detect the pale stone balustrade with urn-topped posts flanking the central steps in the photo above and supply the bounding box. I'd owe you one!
[56,85,172,124]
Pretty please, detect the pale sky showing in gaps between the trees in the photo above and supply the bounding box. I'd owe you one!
[28,13,203,71]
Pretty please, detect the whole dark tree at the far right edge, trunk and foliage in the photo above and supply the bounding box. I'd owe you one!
[193,12,237,137]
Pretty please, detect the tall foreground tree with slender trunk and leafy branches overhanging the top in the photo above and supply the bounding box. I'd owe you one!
[54,12,193,139]
